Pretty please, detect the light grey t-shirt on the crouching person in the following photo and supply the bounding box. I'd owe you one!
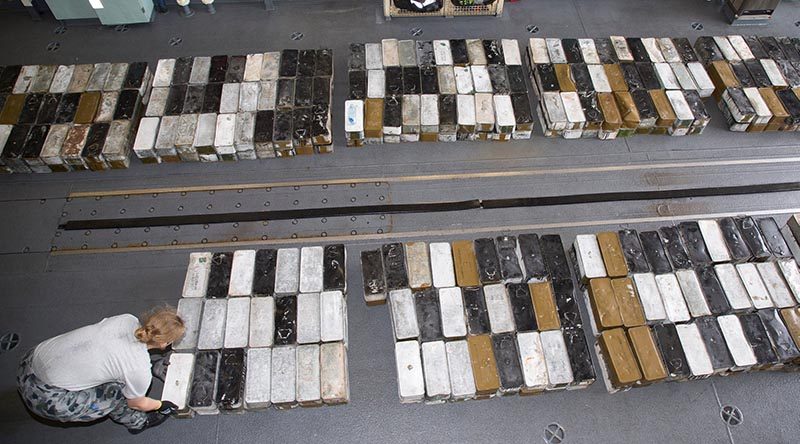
[31,314,152,399]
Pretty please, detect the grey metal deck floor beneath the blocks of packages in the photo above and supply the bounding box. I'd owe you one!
[0,0,800,444]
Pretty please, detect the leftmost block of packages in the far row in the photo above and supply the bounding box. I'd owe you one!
[0,62,151,173]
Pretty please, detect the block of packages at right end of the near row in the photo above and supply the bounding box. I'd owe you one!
[570,217,800,392]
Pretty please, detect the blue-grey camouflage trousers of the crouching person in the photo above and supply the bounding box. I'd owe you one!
[17,350,147,429]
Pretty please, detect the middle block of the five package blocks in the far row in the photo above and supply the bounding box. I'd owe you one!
[345,39,533,146]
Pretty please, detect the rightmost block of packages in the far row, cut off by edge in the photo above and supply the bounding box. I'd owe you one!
[695,35,800,132]
